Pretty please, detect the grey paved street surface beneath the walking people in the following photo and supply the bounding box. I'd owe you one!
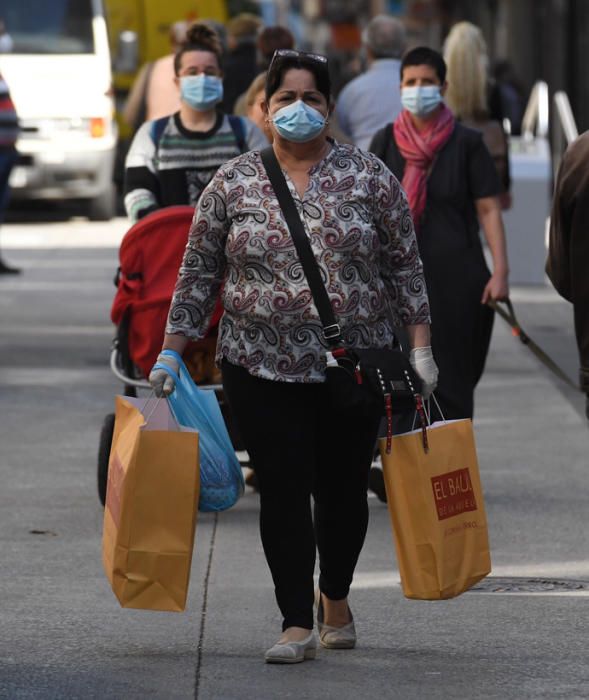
[0,220,589,700]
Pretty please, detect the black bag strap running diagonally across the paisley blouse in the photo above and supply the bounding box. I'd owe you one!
[260,146,342,347]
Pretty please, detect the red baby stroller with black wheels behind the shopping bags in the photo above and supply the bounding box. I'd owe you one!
[98,206,241,505]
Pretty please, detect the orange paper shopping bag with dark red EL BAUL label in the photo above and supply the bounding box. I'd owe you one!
[381,420,491,600]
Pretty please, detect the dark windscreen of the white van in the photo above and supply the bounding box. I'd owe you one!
[0,0,94,54]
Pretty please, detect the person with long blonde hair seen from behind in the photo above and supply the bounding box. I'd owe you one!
[444,22,511,209]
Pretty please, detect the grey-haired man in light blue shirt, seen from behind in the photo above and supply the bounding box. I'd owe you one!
[336,15,406,149]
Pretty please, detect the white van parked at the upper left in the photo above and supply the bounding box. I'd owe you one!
[0,0,117,220]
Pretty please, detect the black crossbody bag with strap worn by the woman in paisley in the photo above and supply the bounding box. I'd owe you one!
[261,146,426,452]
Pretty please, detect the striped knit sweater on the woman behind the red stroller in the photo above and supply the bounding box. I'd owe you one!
[125,112,267,222]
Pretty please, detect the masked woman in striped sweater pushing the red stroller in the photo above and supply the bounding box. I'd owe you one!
[125,23,267,222]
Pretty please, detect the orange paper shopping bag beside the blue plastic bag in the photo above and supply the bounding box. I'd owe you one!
[102,396,199,612]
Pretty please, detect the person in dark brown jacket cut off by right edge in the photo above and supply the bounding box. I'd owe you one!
[546,131,589,418]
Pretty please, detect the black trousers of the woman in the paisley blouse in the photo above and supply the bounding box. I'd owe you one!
[222,361,379,629]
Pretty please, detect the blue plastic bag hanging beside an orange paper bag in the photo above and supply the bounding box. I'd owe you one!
[154,350,245,513]
